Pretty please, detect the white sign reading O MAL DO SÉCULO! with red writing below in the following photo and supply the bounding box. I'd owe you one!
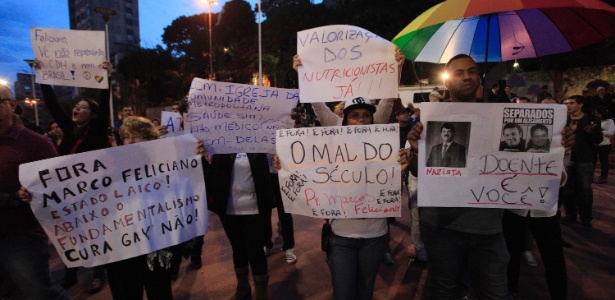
[276,124,402,219]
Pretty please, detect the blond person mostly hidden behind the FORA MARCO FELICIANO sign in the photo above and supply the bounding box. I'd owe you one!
[107,116,174,300]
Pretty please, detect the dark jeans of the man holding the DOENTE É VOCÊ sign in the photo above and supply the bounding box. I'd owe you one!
[420,222,510,299]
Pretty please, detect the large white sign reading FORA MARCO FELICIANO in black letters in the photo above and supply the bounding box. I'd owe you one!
[19,135,207,267]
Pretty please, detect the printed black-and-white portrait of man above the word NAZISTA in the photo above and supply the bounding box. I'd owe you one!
[426,122,466,168]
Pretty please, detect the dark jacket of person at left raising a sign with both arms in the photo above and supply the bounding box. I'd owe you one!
[41,84,111,155]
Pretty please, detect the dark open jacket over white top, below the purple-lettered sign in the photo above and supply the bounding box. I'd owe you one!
[203,153,273,217]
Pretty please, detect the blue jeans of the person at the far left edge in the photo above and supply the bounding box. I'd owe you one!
[0,236,70,300]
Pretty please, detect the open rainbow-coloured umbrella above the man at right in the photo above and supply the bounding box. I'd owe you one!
[393,0,615,63]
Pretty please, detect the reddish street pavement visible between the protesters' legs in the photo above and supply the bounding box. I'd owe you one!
[50,158,615,300]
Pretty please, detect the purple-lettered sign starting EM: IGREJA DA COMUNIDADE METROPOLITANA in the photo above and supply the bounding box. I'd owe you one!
[184,78,299,154]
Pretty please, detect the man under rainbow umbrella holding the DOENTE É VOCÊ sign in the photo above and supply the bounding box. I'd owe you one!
[408,54,570,299]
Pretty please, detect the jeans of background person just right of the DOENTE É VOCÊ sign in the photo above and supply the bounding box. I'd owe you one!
[564,163,594,221]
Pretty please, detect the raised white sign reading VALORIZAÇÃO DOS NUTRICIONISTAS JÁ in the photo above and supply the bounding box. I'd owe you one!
[297,25,399,102]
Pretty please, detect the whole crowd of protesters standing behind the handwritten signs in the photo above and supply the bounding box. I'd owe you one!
[0,44,615,299]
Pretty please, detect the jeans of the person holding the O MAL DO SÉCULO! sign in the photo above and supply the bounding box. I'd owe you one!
[327,234,387,300]
